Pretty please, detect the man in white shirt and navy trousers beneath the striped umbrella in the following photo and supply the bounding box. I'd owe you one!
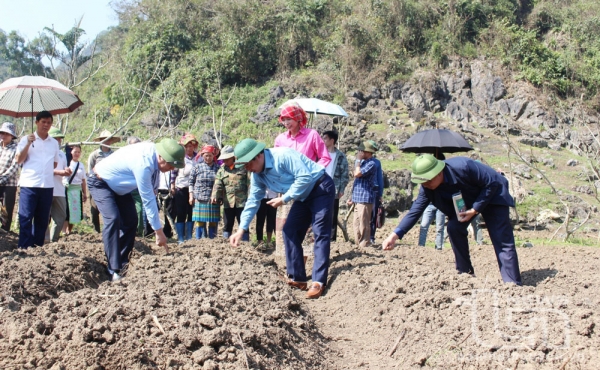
[17,111,60,248]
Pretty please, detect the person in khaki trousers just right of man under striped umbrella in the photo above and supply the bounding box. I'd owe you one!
[46,127,73,242]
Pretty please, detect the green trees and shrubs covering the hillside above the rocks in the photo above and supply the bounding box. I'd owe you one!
[0,0,600,136]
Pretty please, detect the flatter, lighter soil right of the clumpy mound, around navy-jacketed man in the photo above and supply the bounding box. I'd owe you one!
[296,233,600,369]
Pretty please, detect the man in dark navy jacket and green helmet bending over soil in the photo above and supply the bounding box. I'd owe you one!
[383,154,522,285]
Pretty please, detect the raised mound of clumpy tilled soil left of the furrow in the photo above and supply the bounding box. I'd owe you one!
[0,238,324,369]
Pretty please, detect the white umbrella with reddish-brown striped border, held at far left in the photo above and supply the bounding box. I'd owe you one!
[0,76,83,129]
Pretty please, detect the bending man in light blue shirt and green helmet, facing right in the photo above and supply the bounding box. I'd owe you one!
[88,139,184,281]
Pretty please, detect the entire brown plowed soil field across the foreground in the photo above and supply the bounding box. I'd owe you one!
[0,221,600,369]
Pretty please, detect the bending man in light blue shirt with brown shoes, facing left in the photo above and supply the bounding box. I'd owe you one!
[230,139,336,298]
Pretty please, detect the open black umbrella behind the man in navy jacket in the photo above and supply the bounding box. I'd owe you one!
[400,129,473,155]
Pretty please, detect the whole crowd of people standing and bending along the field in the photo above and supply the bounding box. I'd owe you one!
[0,101,521,298]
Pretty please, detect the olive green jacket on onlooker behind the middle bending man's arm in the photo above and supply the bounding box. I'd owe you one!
[211,165,250,208]
